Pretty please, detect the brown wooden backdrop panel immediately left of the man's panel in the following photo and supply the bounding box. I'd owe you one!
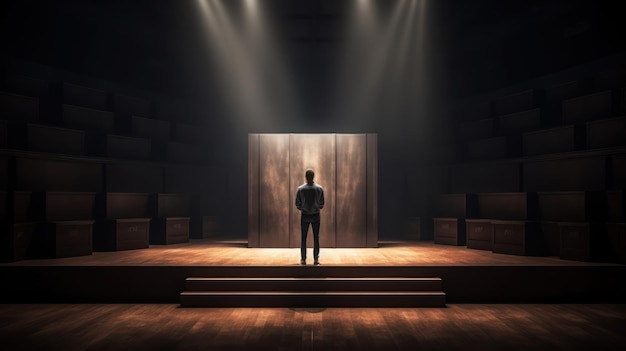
[259,134,293,247]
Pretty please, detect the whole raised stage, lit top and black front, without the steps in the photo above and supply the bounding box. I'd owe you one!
[0,240,626,303]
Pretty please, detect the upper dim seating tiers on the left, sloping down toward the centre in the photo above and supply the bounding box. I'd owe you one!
[0,74,207,163]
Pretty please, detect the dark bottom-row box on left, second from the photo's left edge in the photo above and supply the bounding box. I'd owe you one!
[34,220,94,258]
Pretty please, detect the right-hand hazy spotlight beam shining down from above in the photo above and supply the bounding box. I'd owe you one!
[337,0,427,144]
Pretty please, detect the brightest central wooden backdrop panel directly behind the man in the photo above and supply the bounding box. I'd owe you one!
[289,134,336,248]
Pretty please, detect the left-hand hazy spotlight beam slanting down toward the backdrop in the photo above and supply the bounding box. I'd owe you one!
[196,0,293,132]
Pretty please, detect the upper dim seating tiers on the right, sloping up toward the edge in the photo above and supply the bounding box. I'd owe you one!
[438,69,626,163]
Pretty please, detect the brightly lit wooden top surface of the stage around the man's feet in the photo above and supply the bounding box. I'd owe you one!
[6,240,620,266]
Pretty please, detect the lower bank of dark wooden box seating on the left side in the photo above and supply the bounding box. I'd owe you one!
[0,153,221,261]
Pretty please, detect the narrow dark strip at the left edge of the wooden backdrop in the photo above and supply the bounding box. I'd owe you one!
[248,134,260,247]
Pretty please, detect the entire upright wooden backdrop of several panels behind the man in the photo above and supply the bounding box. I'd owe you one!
[248,134,378,248]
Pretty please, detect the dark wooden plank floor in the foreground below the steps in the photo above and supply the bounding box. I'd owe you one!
[0,304,626,351]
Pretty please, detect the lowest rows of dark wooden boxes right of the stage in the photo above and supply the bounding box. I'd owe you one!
[431,190,626,262]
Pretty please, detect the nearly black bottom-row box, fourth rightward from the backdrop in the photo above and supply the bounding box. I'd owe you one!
[559,222,608,261]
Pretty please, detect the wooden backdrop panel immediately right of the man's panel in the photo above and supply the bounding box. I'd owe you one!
[336,134,367,247]
